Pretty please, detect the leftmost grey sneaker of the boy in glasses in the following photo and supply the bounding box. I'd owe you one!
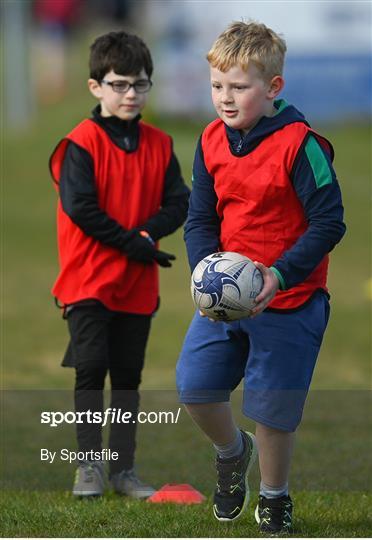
[72,461,105,497]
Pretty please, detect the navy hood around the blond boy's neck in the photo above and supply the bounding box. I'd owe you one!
[225,99,310,156]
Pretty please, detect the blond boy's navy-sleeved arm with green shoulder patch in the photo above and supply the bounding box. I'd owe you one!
[271,135,346,290]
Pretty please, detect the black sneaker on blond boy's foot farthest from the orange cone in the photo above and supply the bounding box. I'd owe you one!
[255,495,293,536]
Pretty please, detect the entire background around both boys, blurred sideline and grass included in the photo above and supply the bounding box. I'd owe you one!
[0,5,372,537]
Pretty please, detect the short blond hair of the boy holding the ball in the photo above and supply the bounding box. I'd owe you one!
[207,21,287,81]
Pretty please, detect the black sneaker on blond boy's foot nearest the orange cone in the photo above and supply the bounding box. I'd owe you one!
[213,431,257,521]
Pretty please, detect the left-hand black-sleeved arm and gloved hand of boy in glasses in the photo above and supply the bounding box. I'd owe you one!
[59,142,174,266]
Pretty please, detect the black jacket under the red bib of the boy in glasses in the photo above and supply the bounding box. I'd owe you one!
[60,105,190,250]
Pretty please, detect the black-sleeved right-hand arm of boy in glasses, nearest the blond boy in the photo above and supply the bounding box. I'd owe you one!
[140,148,190,241]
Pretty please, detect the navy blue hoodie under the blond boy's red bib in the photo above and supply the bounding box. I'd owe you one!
[185,100,346,306]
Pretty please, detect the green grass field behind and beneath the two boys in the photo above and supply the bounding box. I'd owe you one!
[1,51,372,537]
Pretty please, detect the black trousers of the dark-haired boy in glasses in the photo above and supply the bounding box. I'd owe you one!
[63,302,151,474]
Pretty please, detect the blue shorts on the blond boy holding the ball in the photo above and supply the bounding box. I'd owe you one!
[177,291,329,431]
